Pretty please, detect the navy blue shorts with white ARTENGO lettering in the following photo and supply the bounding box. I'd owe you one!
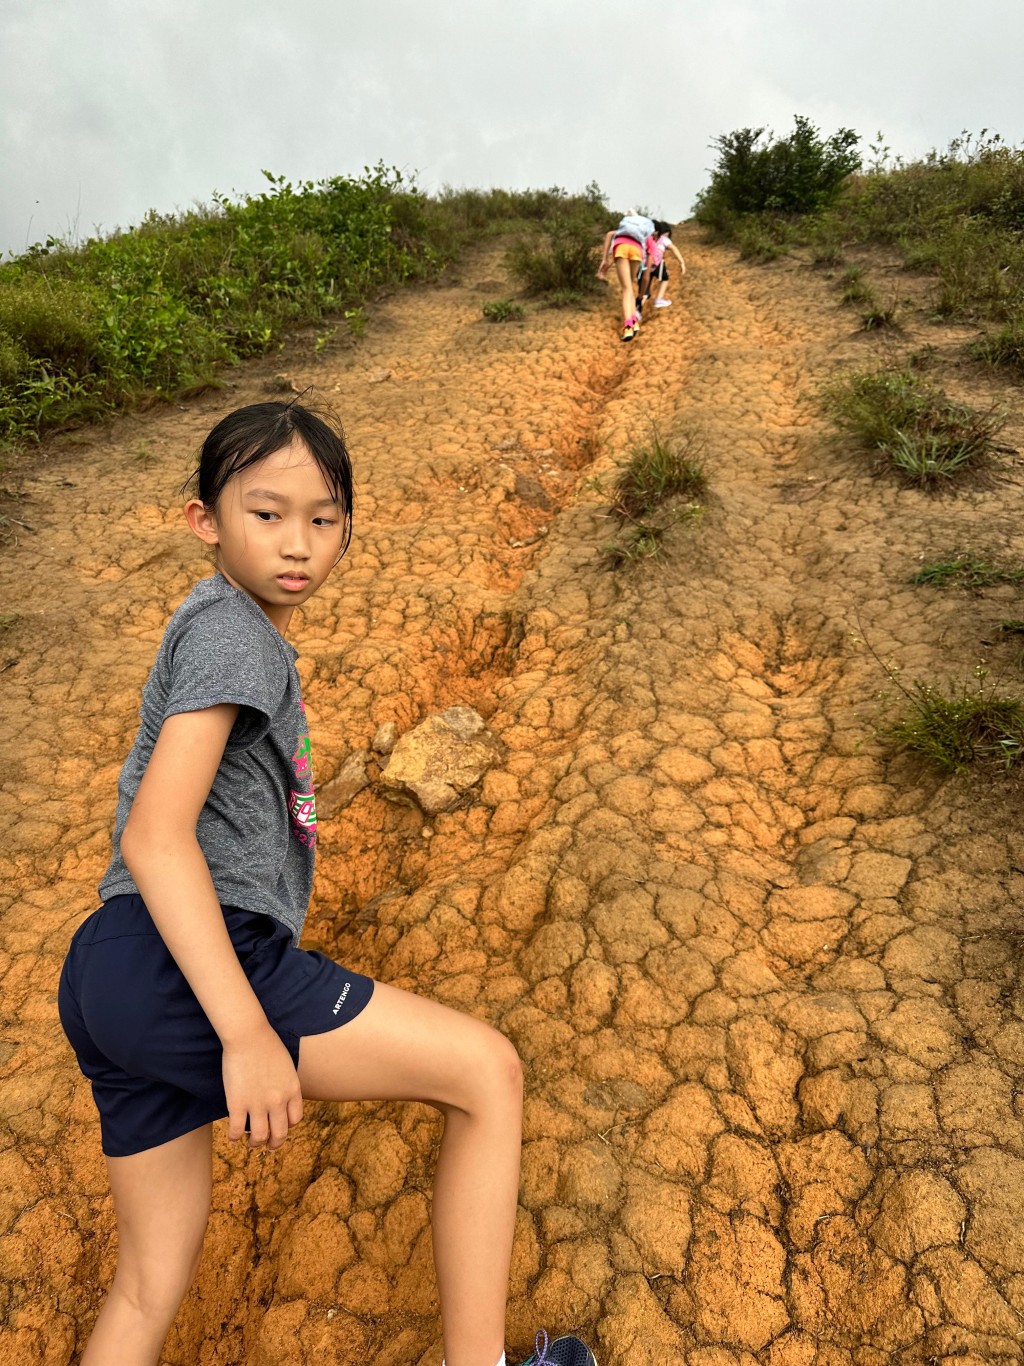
[57,896,373,1157]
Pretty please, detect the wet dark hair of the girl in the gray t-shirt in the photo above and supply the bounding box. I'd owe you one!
[182,400,352,555]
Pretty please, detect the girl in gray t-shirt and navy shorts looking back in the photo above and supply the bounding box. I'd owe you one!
[59,403,594,1366]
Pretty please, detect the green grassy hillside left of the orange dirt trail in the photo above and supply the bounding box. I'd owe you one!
[0,165,605,447]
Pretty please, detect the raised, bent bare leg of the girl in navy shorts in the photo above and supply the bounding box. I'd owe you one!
[296,984,523,1366]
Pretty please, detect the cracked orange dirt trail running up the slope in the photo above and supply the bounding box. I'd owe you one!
[0,239,1024,1366]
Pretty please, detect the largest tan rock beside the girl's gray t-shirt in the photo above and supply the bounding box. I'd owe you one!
[381,706,502,816]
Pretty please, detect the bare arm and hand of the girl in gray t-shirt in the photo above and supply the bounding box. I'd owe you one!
[122,703,302,1147]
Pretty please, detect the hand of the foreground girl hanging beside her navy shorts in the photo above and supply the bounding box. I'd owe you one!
[223,1025,302,1152]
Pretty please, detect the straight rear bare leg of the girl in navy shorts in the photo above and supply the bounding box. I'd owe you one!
[82,1124,212,1366]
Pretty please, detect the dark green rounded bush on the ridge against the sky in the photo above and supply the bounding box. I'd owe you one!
[695,115,860,234]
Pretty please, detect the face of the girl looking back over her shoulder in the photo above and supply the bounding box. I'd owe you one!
[186,440,345,634]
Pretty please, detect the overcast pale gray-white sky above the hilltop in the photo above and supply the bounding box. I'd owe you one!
[0,0,1024,251]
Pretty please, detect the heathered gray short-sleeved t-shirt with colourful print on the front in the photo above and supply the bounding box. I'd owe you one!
[100,574,317,941]
